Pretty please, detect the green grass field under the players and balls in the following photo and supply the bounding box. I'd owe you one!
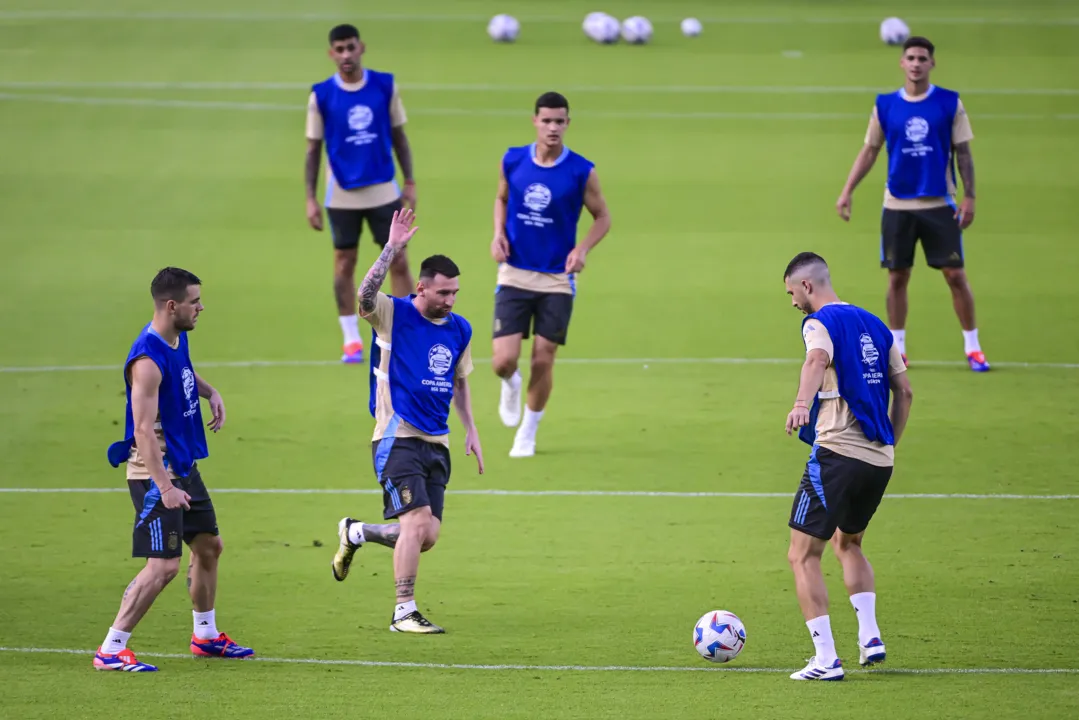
[0,0,1079,720]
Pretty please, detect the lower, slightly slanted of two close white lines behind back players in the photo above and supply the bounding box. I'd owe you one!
[0,93,1079,121]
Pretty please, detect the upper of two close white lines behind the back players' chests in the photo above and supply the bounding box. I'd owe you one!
[0,80,1079,96]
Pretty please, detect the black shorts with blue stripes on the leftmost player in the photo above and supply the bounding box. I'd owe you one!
[127,467,218,558]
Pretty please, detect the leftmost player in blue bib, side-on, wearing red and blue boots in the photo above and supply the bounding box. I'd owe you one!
[94,268,255,673]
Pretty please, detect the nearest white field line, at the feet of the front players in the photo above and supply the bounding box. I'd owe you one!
[0,647,1079,675]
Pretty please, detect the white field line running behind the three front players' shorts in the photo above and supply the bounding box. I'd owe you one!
[0,487,1079,501]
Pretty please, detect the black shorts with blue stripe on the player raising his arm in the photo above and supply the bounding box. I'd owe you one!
[371,437,450,520]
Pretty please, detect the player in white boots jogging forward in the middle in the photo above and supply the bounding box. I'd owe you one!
[491,93,611,458]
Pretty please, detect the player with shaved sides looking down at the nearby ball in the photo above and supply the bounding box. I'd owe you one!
[783,253,913,680]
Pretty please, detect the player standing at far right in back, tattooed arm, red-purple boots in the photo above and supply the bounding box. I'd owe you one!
[835,37,989,372]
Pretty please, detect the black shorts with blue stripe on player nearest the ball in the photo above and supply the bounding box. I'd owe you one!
[788,445,892,540]
